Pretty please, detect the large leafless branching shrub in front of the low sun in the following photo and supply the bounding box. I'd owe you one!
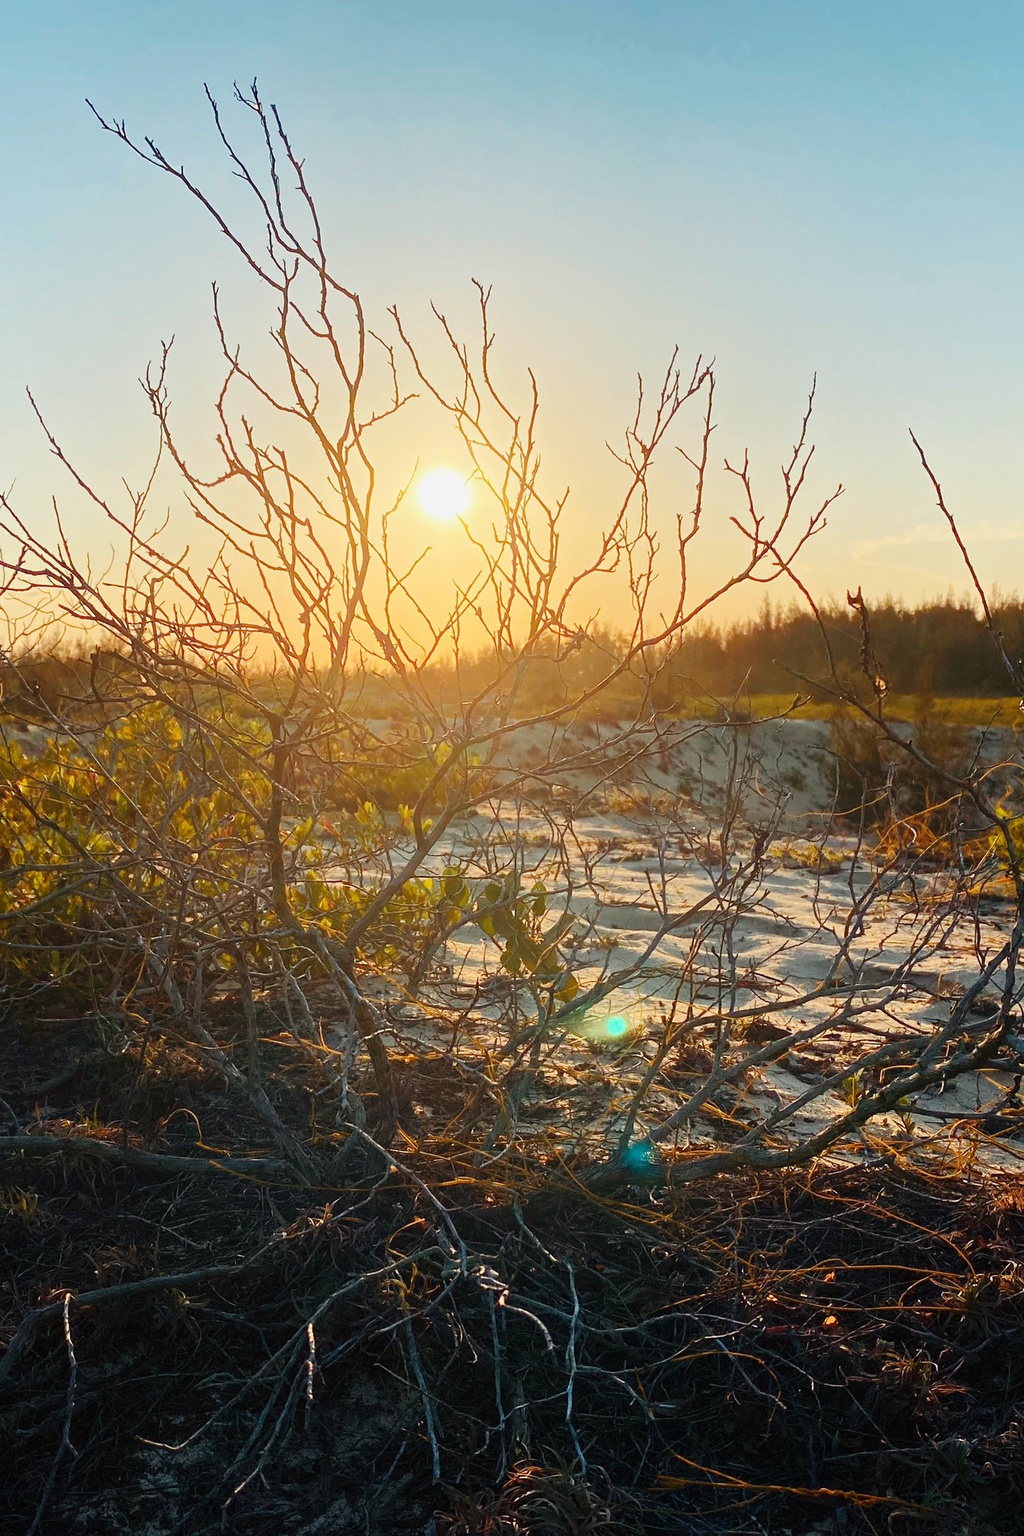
[0,88,1024,1528]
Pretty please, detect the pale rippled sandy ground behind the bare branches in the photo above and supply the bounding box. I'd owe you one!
[330,720,1024,1167]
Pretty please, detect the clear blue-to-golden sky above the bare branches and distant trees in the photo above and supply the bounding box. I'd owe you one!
[0,0,1024,626]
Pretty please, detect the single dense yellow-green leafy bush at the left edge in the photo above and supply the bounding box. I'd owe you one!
[0,705,266,995]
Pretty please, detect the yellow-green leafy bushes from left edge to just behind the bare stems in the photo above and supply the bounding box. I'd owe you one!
[0,703,460,1003]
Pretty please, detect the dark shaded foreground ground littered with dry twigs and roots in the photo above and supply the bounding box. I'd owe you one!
[0,1018,1024,1536]
